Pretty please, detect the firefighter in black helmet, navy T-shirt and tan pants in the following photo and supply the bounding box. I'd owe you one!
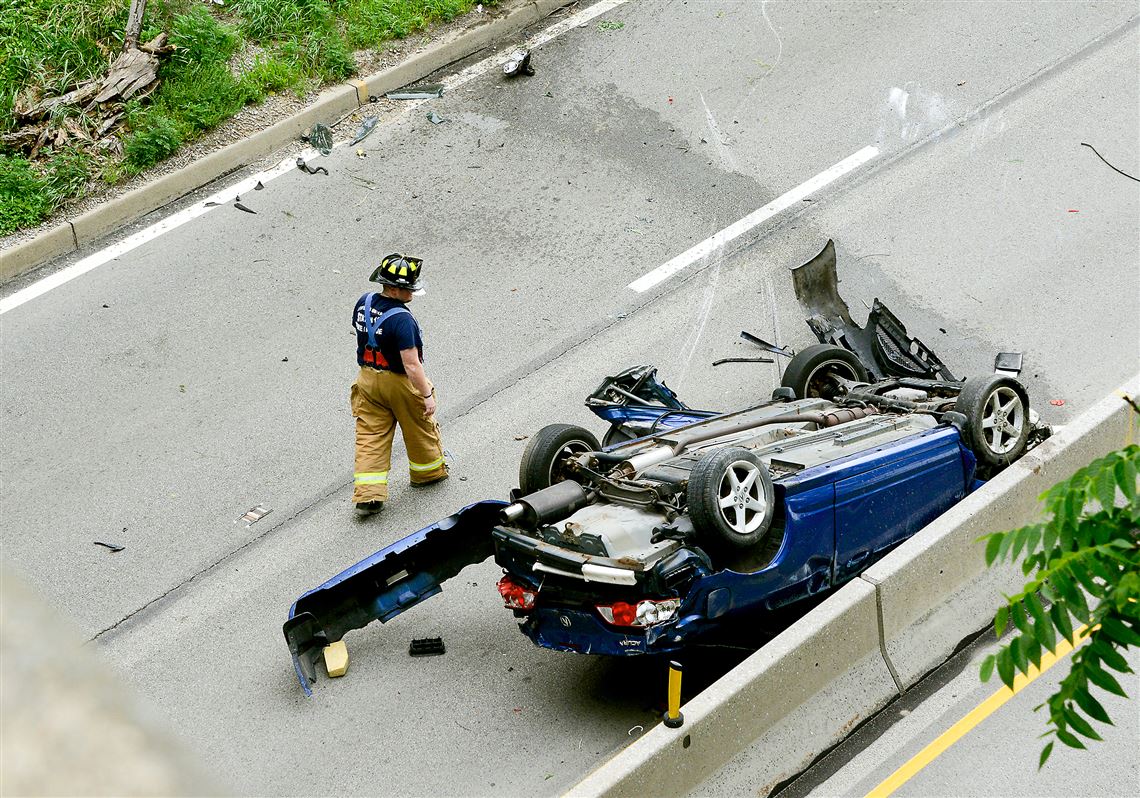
[350,253,447,515]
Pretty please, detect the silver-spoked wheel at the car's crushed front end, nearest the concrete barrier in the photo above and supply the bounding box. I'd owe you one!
[954,374,1031,469]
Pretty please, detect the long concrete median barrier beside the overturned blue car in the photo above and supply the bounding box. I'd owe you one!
[567,374,1140,798]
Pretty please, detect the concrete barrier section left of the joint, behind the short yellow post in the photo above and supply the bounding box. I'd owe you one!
[569,579,896,798]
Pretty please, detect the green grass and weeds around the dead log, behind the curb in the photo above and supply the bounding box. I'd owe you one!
[0,0,485,235]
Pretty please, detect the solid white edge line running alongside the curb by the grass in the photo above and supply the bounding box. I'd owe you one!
[0,0,628,316]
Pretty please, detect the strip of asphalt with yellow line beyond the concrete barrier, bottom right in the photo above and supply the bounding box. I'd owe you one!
[770,635,1140,798]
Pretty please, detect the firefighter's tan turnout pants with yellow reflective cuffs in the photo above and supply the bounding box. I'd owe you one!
[350,367,447,504]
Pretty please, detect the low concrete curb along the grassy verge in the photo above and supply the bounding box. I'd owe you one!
[0,0,573,283]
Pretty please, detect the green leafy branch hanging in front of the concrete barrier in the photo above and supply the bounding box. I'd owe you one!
[982,417,1140,767]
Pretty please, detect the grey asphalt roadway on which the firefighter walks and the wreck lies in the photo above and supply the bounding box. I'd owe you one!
[0,2,1140,795]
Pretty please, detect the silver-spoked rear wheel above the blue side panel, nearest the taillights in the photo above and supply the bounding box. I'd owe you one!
[689,446,775,551]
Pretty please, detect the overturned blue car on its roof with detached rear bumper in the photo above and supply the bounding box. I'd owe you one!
[284,238,1048,693]
